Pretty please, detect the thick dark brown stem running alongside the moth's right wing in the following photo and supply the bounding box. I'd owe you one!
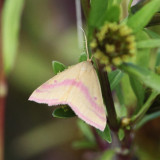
[98,64,119,131]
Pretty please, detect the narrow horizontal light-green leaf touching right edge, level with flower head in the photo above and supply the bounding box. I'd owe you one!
[137,39,160,48]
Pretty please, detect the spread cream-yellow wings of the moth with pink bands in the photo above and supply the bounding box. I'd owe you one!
[29,61,106,131]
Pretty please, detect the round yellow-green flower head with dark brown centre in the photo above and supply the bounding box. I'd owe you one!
[90,23,136,71]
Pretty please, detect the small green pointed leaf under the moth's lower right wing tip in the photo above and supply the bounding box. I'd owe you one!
[97,124,112,143]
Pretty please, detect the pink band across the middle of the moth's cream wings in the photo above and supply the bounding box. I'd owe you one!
[36,79,105,113]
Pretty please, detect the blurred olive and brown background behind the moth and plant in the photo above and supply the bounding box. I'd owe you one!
[2,0,160,160]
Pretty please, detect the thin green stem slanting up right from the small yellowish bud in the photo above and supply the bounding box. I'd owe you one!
[131,91,158,125]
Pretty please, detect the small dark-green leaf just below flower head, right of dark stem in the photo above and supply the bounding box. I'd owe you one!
[108,69,123,90]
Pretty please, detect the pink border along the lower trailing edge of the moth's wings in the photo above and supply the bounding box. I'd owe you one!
[29,97,106,131]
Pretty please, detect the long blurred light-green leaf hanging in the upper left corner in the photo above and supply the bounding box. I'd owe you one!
[2,0,24,74]
